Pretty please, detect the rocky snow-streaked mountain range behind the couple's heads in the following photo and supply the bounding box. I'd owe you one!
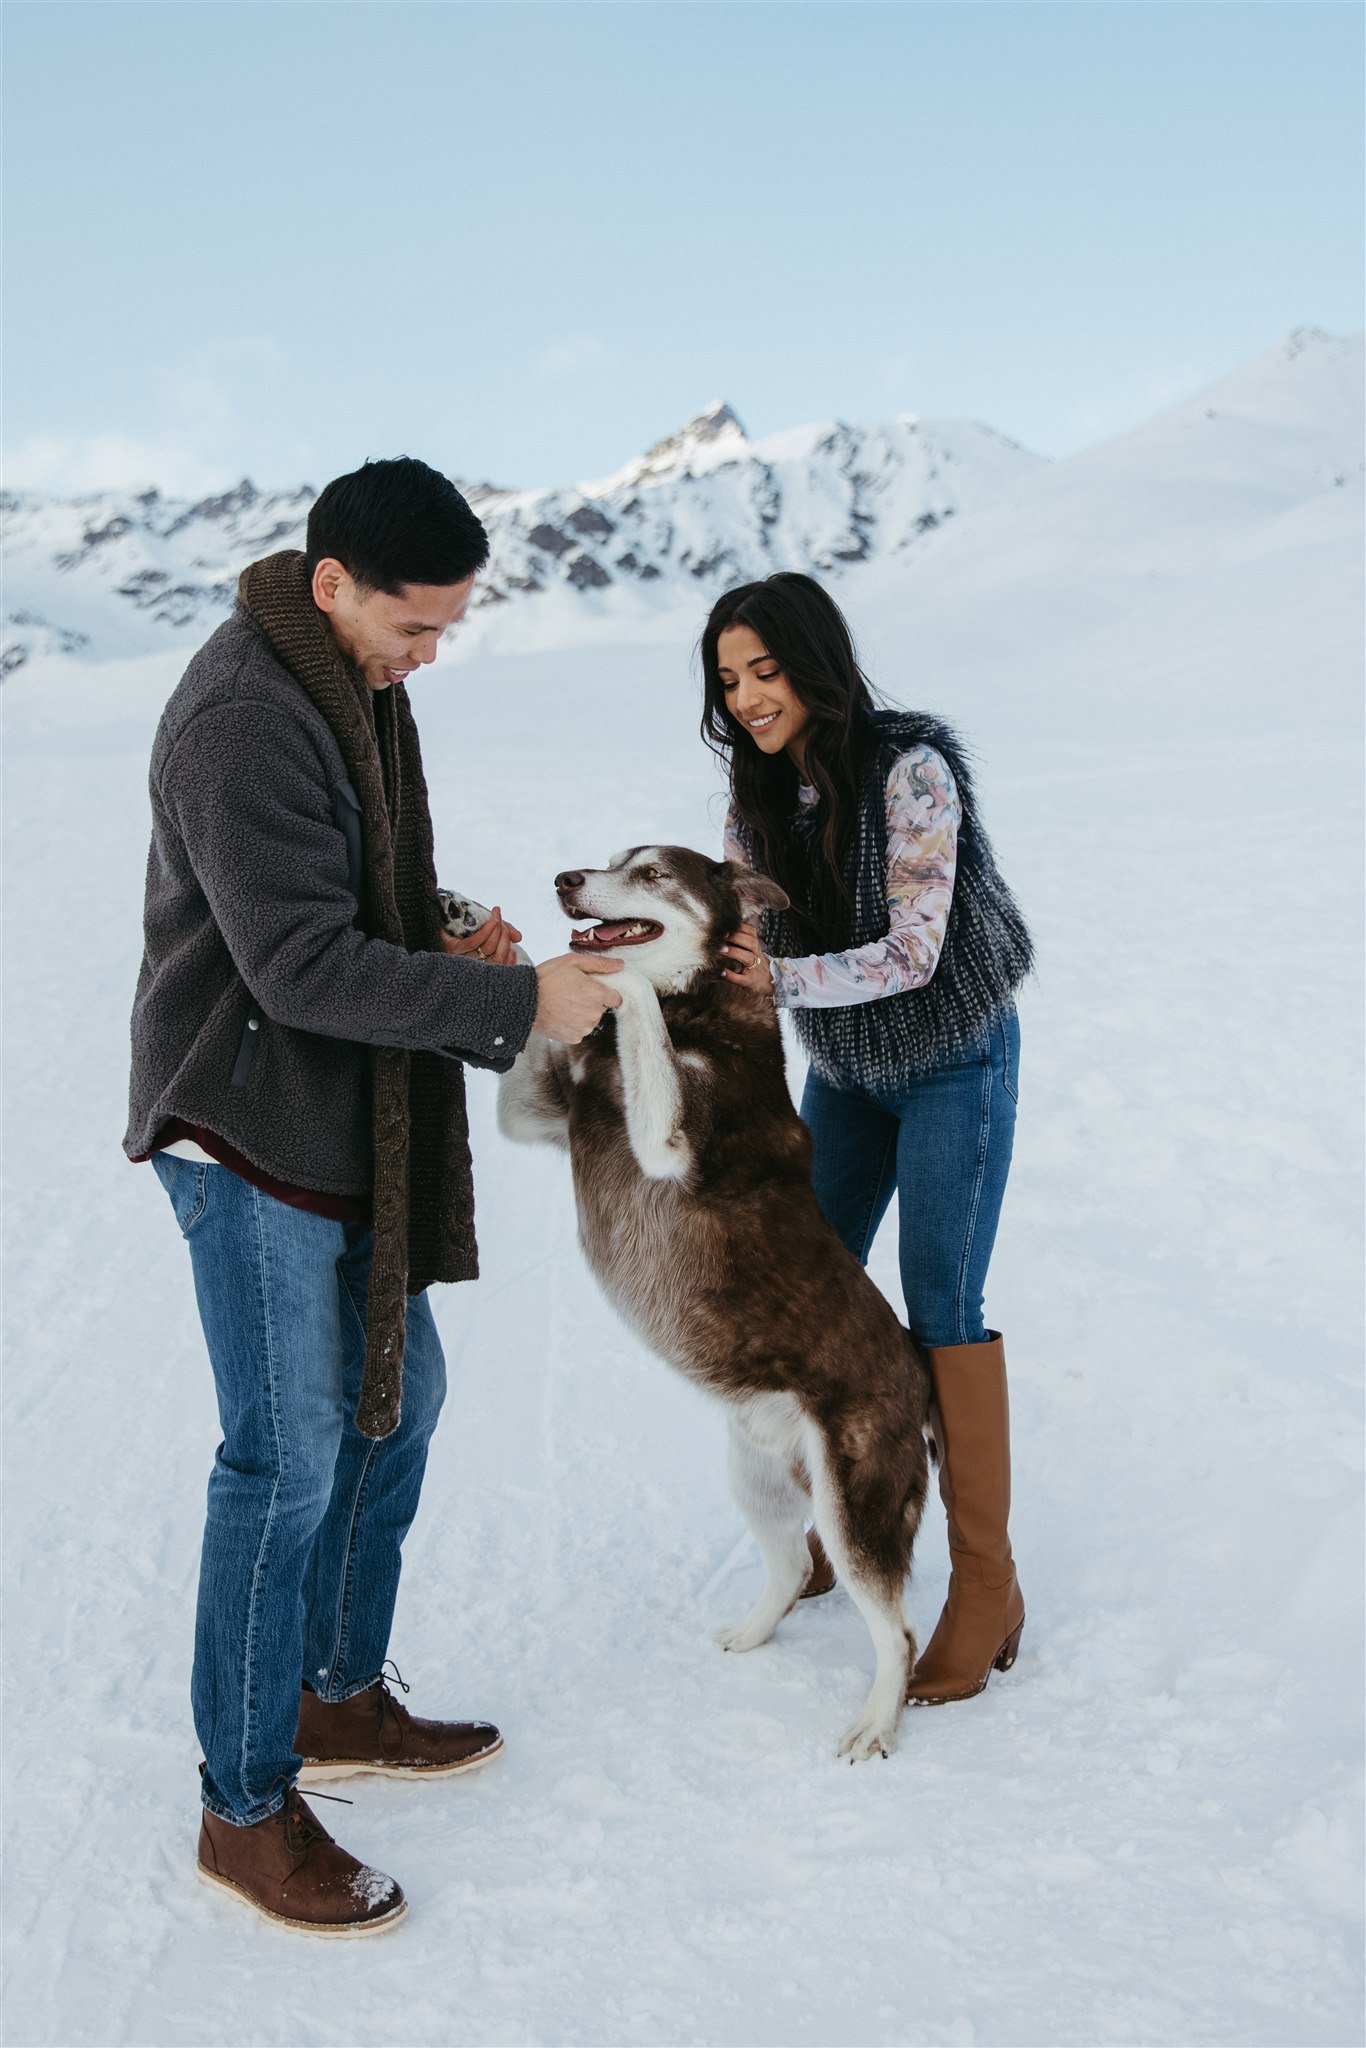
[0,391,1040,674]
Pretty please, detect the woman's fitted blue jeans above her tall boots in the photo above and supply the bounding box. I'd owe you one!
[801,1010,1020,1346]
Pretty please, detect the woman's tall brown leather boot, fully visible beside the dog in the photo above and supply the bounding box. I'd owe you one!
[909,1329,1024,1706]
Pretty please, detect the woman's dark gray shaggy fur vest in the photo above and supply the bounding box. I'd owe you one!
[737,711,1034,1087]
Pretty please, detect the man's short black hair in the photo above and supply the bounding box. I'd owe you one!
[305,455,489,598]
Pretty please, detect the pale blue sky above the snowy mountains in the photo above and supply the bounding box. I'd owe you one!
[2,0,1364,492]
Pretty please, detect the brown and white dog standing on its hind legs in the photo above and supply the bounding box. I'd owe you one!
[479,846,930,1759]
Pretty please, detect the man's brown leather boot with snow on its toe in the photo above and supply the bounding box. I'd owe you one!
[199,1786,408,1935]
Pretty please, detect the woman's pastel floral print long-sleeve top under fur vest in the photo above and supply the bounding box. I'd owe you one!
[723,745,963,1010]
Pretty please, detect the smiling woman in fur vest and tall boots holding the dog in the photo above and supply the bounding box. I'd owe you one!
[702,573,1032,1706]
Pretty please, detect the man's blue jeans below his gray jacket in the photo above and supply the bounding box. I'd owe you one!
[154,1153,446,1825]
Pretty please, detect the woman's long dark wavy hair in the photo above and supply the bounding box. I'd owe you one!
[700,569,874,950]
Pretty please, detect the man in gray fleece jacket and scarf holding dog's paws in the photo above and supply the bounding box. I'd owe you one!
[125,459,621,1933]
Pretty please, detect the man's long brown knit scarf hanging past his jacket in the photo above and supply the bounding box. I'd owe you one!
[238,549,479,1436]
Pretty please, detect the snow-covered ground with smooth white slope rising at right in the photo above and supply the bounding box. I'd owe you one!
[4,339,1362,2048]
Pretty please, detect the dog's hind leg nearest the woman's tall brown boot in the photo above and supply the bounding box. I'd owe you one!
[807,1423,915,1763]
